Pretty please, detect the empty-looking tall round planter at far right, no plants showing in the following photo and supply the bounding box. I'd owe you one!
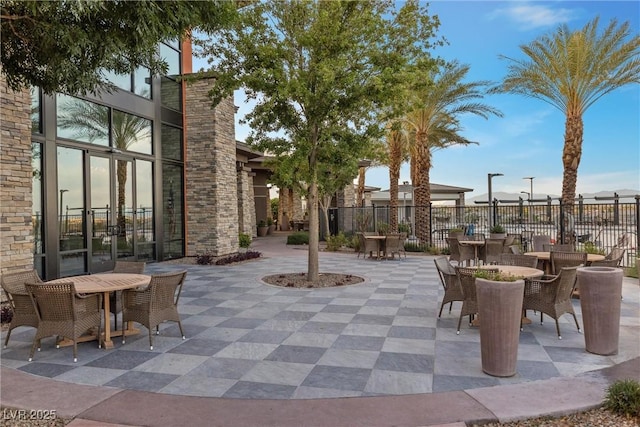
[577,267,623,356]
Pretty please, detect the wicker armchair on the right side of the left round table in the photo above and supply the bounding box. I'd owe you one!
[122,271,187,350]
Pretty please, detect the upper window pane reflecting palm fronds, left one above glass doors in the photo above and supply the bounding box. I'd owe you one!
[57,95,109,146]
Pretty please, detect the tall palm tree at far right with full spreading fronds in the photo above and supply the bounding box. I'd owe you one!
[493,17,640,212]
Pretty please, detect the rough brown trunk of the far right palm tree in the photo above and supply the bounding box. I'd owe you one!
[562,115,584,214]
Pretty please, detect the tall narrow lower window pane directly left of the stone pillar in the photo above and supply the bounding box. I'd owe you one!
[162,163,184,259]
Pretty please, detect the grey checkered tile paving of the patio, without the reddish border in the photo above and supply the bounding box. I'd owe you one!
[1,250,640,399]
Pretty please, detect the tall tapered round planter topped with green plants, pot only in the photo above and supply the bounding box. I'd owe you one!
[476,278,524,377]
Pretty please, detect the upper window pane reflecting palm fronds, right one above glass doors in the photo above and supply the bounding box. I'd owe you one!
[112,110,152,154]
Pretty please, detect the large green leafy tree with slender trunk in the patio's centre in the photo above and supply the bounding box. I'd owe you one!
[201,0,438,281]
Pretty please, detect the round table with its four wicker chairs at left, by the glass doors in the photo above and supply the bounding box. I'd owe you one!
[1,261,187,362]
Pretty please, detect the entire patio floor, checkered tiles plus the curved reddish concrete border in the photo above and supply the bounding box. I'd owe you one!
[0,234,640,426]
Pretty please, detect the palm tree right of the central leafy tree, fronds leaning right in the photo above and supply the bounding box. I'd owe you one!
[403,61,502,246]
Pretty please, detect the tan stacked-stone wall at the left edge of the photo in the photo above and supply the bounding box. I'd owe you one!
[0,77,33,273]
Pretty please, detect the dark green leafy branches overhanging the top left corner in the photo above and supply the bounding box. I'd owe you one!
[0,0,235,94]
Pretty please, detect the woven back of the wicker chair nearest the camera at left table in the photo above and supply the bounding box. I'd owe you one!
[25,282,76,322]
